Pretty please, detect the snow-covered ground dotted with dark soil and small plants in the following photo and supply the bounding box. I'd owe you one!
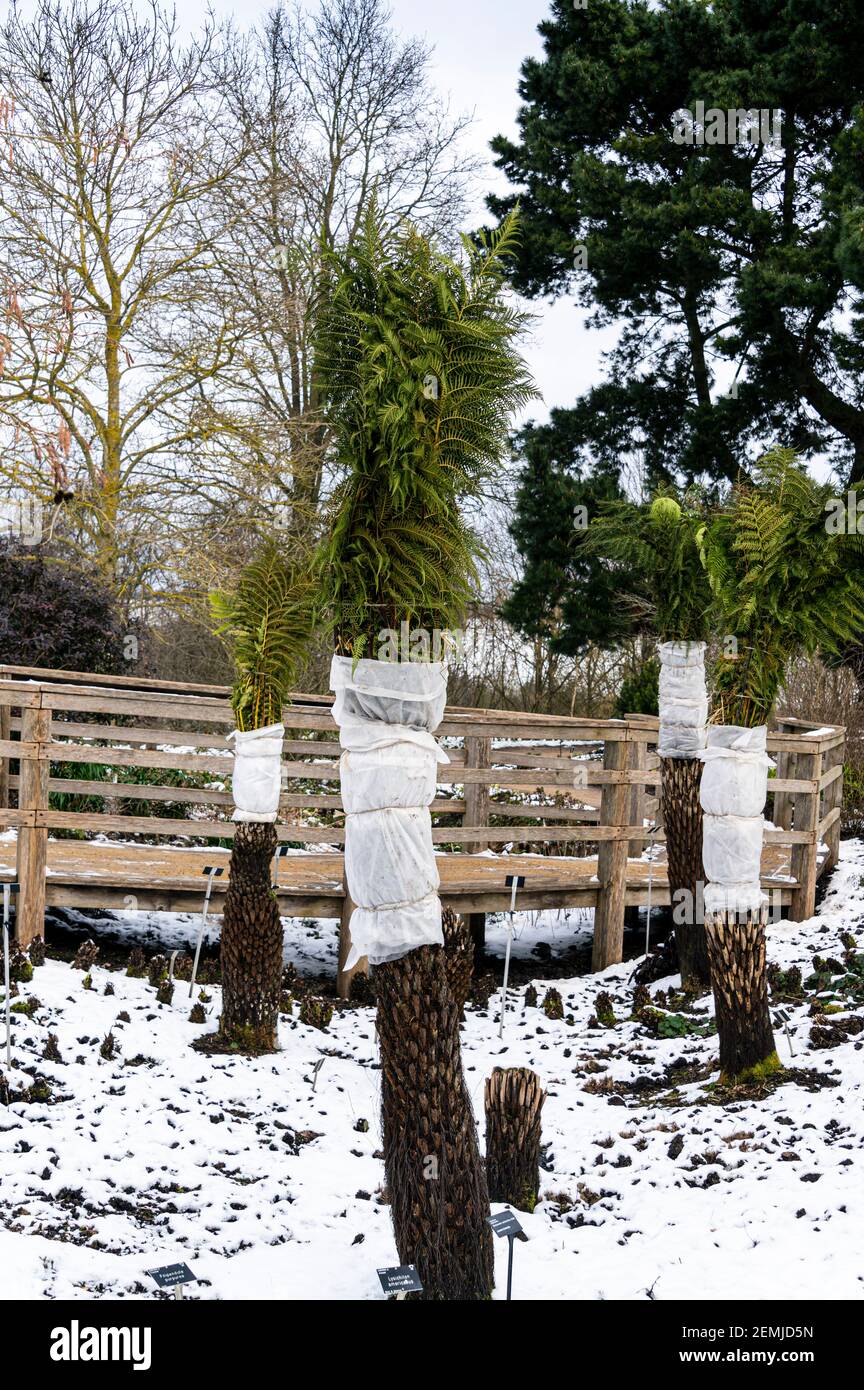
[0,841,864,1300]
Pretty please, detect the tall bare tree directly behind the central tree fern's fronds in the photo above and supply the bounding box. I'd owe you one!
[198,0,472,539]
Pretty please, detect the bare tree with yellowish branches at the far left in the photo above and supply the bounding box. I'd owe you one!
[0,0,249,608]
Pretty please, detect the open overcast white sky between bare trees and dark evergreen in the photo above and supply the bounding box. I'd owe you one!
[195,0,615,418]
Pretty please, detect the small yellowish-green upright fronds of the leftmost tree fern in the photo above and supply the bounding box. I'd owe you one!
[210,542,314,730]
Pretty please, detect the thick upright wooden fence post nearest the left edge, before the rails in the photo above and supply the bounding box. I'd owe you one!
[15,706,51,947]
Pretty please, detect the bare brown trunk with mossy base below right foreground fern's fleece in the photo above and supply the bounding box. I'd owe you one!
[706,913,781,1084]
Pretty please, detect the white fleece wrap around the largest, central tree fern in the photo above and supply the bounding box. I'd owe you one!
[331,656,450,969]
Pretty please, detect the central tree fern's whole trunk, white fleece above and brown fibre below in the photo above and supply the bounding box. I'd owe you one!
[331,656,493,1301]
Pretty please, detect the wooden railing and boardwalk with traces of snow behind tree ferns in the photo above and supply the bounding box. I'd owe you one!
[0,666,845,969]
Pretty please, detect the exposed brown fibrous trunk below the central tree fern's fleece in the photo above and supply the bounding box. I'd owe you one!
[374,947,493,1301]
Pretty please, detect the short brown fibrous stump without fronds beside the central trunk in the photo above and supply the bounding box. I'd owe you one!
[485,1066,546,1212]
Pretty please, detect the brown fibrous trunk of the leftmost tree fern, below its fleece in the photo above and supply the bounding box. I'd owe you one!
[219,821,282,1052]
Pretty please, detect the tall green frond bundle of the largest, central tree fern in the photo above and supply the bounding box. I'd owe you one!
[317,207,533,656]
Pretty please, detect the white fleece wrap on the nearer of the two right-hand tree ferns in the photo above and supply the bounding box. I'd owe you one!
[700,724,775,917]
